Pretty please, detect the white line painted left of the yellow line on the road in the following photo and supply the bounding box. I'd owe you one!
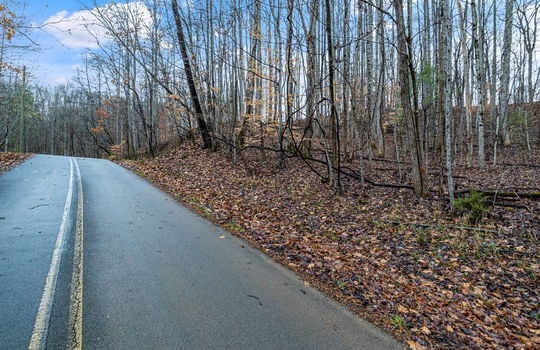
[28,158,73,350]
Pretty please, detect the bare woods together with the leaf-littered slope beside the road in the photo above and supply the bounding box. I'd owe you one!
[0,0,540,349]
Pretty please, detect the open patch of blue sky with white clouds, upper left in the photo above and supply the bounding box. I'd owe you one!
[13,0,119,86]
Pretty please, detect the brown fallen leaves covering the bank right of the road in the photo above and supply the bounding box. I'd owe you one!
[122,146,540,349]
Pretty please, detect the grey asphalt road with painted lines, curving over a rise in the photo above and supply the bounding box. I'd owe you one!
[0,156,403,349]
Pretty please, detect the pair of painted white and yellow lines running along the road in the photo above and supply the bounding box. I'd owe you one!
[28,158,84,350]
